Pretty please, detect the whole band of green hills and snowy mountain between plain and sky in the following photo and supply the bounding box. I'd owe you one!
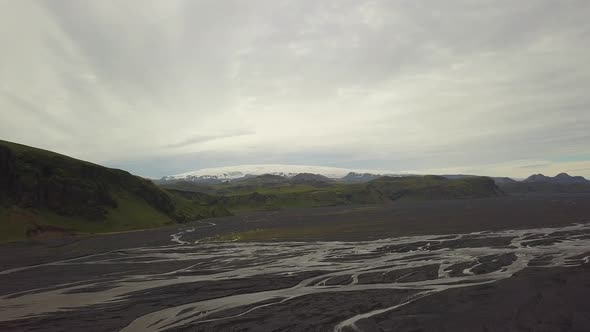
[0,141,590,241]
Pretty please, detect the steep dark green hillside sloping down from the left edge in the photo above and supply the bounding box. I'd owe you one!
[0,141,229,241]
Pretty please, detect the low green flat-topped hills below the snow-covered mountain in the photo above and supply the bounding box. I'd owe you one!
[166,176,503,213]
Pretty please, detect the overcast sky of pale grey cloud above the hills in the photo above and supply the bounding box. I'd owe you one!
[0,0,590,177]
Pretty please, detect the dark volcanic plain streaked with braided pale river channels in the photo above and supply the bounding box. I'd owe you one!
[0,194,590,331]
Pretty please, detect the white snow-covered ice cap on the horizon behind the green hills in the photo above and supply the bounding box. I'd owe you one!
[158,164,402,184]
